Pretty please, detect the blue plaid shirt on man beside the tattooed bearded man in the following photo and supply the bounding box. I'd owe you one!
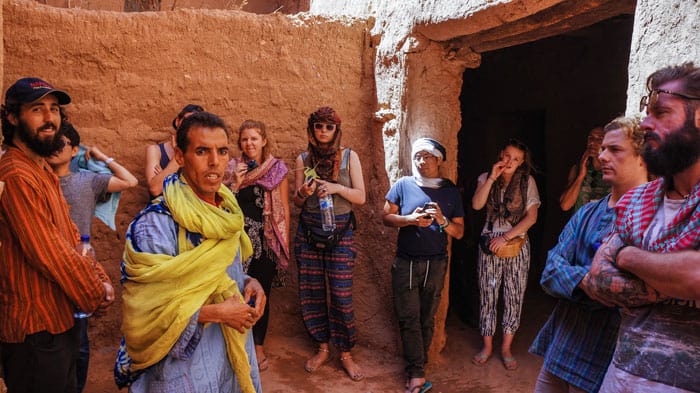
[530,196,620,392]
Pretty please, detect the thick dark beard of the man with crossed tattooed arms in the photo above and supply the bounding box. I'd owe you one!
[642,112,700,177]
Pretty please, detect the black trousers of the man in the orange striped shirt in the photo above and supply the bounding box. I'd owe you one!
[1,326,80,393]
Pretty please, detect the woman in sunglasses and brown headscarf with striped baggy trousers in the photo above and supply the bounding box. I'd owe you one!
[293,107,365,381]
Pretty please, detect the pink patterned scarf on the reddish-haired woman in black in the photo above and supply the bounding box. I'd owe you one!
[226,156,289,269]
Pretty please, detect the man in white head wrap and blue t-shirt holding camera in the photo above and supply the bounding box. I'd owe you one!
[383,138,464,393]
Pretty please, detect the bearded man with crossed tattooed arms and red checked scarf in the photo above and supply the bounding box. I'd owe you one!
[584,63,700,392]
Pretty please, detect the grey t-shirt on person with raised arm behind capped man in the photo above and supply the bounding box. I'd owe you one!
[59,172,112,235]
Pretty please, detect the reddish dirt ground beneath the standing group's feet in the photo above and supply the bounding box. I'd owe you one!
[85,288,554,393]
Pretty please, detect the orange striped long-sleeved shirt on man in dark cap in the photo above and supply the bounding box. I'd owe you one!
[0,147,109,343]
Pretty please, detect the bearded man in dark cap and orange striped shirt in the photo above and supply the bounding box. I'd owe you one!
[0,78,114,392]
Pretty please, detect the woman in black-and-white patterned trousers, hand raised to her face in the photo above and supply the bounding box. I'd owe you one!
[472,139,540,370]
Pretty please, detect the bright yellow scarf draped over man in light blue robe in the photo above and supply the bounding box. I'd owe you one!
[122,175,255,393]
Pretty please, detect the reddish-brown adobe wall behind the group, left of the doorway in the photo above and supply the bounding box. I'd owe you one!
[3,0,395,348]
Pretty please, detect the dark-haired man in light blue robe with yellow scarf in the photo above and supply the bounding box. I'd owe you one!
[115,112,266,393]
